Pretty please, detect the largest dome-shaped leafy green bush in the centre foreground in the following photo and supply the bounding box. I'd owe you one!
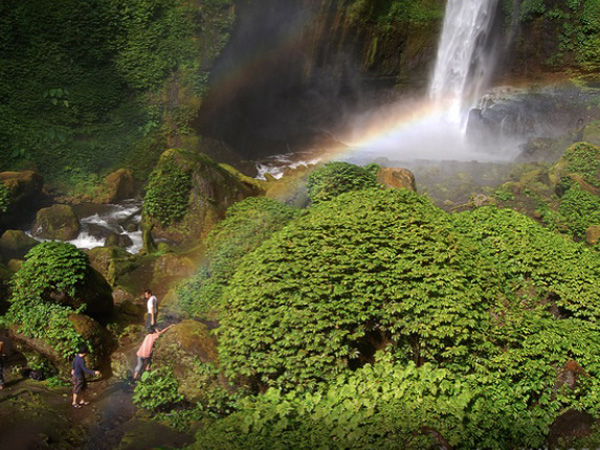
[219,189,494,388]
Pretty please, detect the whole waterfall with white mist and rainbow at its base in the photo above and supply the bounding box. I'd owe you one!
[338,0,512,164]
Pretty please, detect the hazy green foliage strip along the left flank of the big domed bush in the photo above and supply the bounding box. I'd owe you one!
[177,197,300,316]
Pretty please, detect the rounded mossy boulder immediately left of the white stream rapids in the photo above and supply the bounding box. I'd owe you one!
[33,205,80,241]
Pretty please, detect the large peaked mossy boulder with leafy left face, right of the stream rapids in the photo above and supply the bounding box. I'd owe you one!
[142,149,262,250]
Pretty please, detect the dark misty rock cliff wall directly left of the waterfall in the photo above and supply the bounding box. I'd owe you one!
[196,0,445,158]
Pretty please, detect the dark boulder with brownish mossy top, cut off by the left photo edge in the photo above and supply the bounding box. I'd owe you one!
[0,170,44,230]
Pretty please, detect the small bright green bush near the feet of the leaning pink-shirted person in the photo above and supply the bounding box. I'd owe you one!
[133,367,183,413]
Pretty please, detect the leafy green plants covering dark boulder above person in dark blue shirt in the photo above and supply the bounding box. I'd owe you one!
[2,242,89,358]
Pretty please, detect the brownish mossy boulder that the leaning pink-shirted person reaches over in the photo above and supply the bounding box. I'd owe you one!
[154,320,218,401]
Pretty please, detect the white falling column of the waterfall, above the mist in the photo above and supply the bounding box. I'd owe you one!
[429,0,498,122]
